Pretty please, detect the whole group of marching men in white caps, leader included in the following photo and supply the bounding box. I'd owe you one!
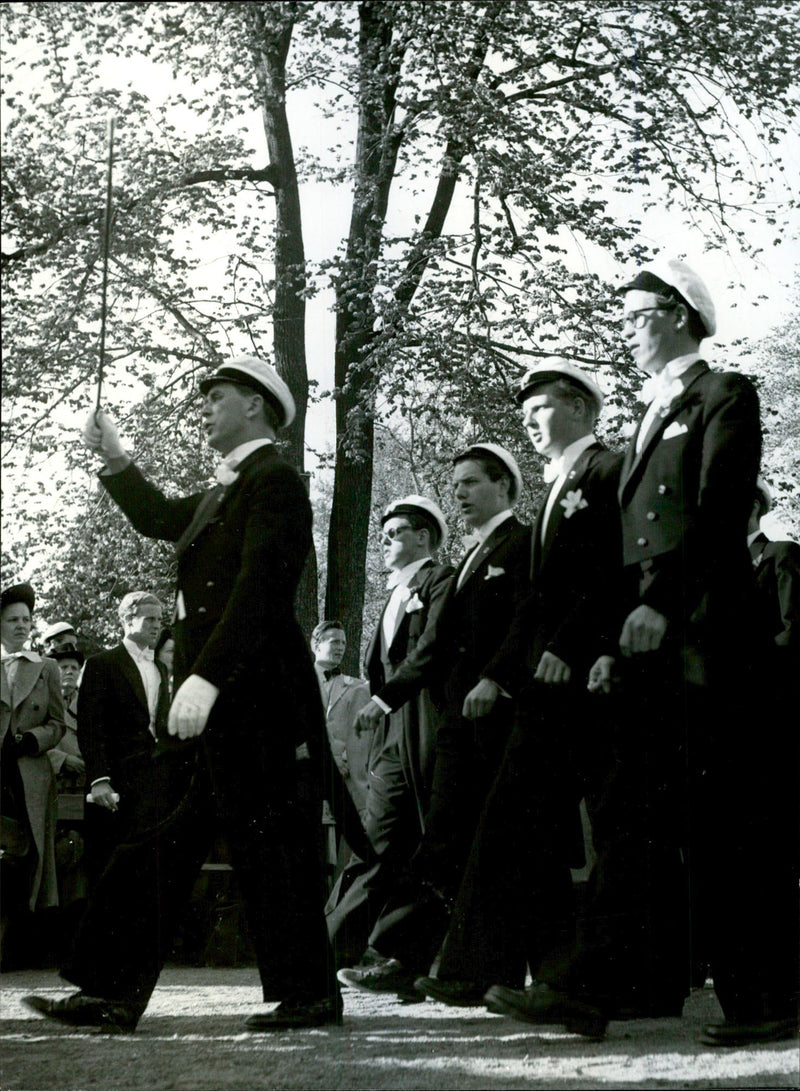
[15,253,800,1045]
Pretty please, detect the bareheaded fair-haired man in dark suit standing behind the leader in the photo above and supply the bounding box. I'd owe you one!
[77,591,169,886]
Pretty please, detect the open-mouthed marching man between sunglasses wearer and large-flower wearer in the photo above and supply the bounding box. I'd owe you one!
[338,443,530,998]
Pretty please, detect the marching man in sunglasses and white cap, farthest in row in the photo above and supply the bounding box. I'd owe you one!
[327,494,453,966]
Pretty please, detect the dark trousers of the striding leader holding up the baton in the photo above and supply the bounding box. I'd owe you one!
[61,730,337,1009]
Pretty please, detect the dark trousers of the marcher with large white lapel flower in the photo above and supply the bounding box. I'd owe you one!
[430,684,596,987]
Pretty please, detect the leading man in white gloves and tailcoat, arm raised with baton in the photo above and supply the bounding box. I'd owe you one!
[31,357,342,1031]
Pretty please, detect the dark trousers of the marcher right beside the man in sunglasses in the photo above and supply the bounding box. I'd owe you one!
[370,698,512,974]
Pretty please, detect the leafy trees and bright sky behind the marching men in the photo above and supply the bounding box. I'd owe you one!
[0,0,800,668]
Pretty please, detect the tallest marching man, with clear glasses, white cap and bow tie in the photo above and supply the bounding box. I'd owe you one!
[487,261,798,1046]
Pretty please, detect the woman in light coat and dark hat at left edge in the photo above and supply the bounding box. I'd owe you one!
[0,584,64,960]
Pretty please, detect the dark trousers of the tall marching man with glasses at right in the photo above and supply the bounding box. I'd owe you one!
[539,648,798,1021]
